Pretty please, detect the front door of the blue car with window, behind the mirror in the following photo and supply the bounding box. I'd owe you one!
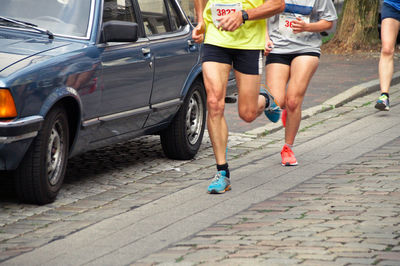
[99,0,153,138]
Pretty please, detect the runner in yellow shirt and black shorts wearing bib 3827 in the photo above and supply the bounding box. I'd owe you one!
[192,0,285,194]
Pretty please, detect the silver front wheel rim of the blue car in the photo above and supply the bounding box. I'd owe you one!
[46,122,64,186]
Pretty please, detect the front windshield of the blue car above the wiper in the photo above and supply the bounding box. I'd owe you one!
[0,0,94,38]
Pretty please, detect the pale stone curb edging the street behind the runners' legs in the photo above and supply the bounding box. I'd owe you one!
[244,71,400,137]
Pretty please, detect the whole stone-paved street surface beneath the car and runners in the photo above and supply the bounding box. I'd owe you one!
[0,73,400,265]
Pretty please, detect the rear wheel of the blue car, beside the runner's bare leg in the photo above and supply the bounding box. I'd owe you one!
[160,80,207,160]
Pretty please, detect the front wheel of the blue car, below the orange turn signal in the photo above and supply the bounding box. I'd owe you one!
[15,107,69,205]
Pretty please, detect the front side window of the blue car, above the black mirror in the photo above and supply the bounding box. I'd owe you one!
[103,0,137,22]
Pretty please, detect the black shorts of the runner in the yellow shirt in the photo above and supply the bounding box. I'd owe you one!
[202,44,263,75]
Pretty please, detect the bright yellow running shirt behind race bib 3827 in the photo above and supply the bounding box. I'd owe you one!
[203,0,266,50]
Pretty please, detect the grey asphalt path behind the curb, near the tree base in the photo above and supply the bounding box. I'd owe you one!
[225,52,400,133]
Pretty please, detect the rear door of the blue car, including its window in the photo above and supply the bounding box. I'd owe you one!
[137,0,199,126]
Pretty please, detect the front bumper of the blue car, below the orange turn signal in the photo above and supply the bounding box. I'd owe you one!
[0,116,44,170]
